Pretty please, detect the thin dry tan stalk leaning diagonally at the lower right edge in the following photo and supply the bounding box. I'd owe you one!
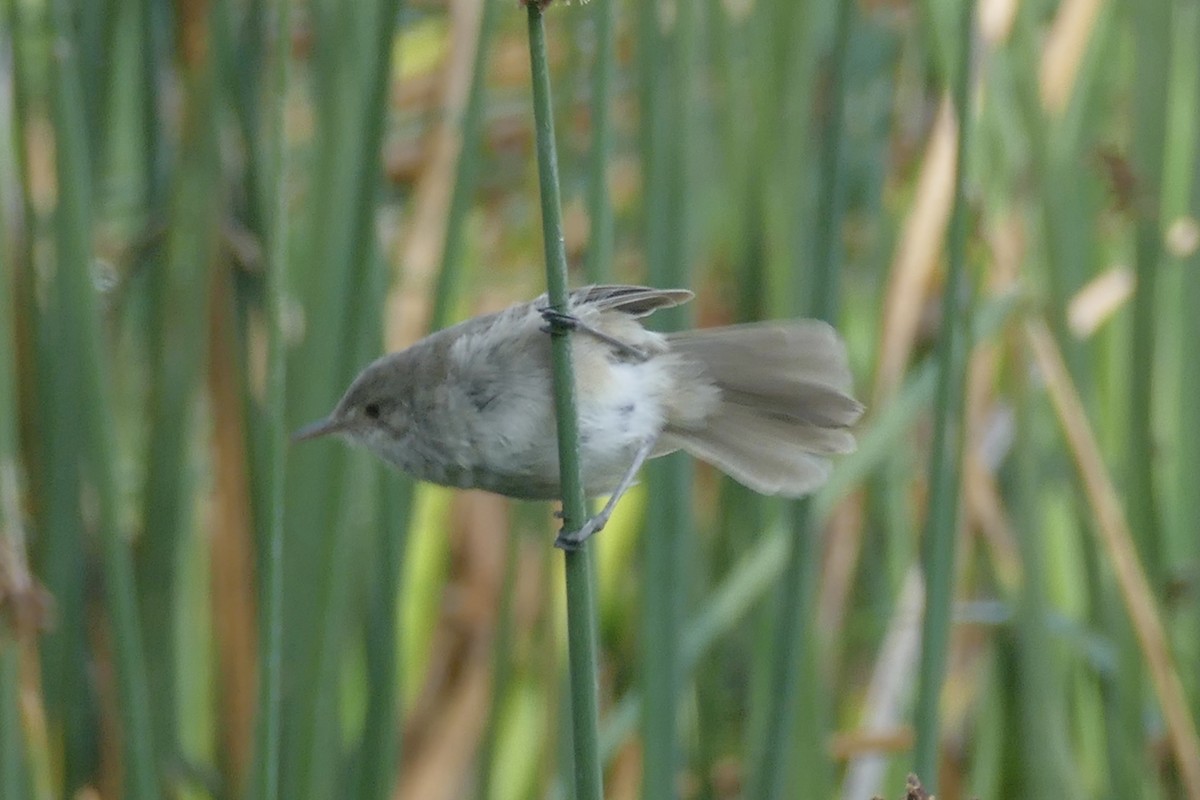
[1025,318,1200,800]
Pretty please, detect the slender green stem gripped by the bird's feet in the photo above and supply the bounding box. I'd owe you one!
[528,2,604,800]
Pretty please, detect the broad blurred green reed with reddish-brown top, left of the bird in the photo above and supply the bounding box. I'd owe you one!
[137,0,221,757]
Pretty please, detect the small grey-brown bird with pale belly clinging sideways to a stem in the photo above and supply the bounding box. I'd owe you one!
[294,285,863,548]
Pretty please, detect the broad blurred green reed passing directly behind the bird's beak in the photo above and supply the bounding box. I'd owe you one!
[281,0,401,800]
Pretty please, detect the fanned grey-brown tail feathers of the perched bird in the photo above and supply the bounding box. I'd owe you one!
[659,320,863,498]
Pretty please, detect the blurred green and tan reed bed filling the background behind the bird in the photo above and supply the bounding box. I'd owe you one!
[0,0,1200,800]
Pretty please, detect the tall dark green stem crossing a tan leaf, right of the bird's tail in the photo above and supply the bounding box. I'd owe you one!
[914,0,974,793]
